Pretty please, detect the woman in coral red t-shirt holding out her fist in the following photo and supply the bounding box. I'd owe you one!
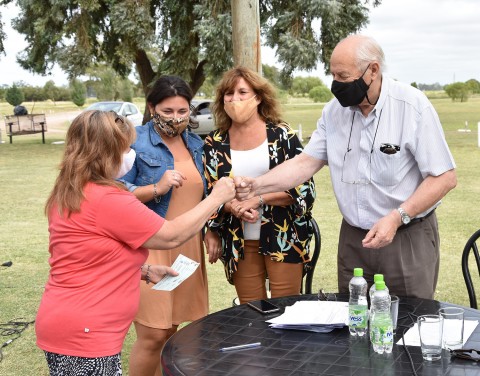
[35,111,235,375]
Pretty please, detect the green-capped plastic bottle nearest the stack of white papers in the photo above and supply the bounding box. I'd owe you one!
[348,268,368,337]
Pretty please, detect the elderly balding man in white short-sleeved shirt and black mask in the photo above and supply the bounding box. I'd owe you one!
[235,35,457,298]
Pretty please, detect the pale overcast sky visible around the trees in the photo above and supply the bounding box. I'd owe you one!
[0,0,480,86]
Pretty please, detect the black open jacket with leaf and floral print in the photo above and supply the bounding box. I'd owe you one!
[203,123,315,284]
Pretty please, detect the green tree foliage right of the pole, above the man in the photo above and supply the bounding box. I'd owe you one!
[260,0,381,83]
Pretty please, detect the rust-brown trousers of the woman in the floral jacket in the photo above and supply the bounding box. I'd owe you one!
[233,240,303,304]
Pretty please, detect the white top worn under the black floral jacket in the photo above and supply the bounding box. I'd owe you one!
[230,139,270,240]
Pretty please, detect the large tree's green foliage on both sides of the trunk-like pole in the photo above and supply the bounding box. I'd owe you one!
[0,0,381,101]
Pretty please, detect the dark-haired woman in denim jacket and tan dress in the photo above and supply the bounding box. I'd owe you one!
[121,76,213,375]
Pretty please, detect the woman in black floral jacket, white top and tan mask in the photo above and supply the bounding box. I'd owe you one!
[204,67,315,303]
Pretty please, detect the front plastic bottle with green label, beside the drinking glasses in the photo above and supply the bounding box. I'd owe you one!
[370,281,393,354]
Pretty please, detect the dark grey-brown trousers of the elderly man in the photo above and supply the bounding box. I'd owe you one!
[337,213,440,299]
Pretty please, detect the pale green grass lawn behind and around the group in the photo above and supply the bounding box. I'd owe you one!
[0,97,480,376]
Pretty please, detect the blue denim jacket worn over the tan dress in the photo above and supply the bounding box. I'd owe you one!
[119,121,207,217]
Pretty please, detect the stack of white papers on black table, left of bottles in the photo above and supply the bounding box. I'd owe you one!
[267,301,348,333]
